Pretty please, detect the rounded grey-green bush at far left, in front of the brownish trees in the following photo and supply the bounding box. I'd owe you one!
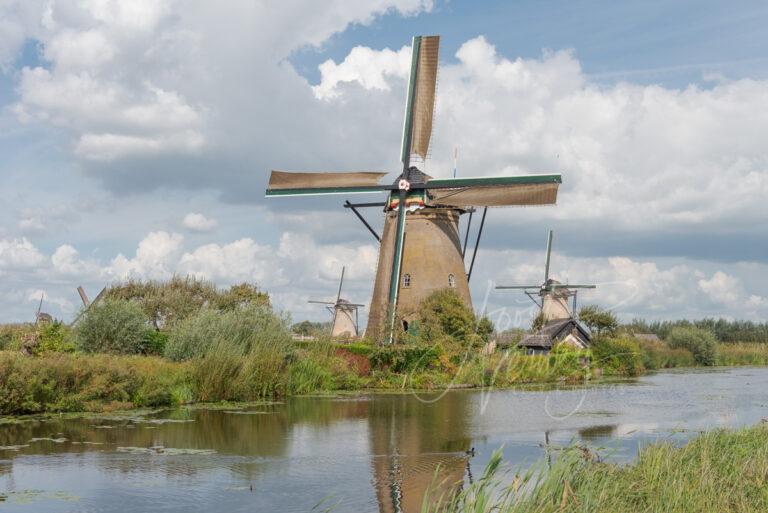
[77,299,148,354]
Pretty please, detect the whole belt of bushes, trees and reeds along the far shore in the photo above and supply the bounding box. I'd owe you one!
[0,278,768,415]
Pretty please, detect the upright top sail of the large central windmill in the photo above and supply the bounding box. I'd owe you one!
[401,36,440,163]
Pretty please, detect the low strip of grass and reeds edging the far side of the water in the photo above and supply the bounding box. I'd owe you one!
[0,341,768,415]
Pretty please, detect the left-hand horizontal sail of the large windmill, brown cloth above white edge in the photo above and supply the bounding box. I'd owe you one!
[266,170,387,197]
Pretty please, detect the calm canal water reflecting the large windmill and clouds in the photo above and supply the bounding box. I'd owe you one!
[0,368,768,513]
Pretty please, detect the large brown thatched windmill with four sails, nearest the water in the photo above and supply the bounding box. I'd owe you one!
[266,36,561,342]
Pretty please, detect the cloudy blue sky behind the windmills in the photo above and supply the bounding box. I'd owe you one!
[0,0,768,328]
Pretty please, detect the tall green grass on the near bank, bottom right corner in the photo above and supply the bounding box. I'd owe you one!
[422,424,768,513]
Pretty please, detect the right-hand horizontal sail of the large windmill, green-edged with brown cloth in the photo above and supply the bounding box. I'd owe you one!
[426,175,562,208]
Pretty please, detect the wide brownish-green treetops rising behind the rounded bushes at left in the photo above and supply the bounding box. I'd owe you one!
[104,276,270,330]
